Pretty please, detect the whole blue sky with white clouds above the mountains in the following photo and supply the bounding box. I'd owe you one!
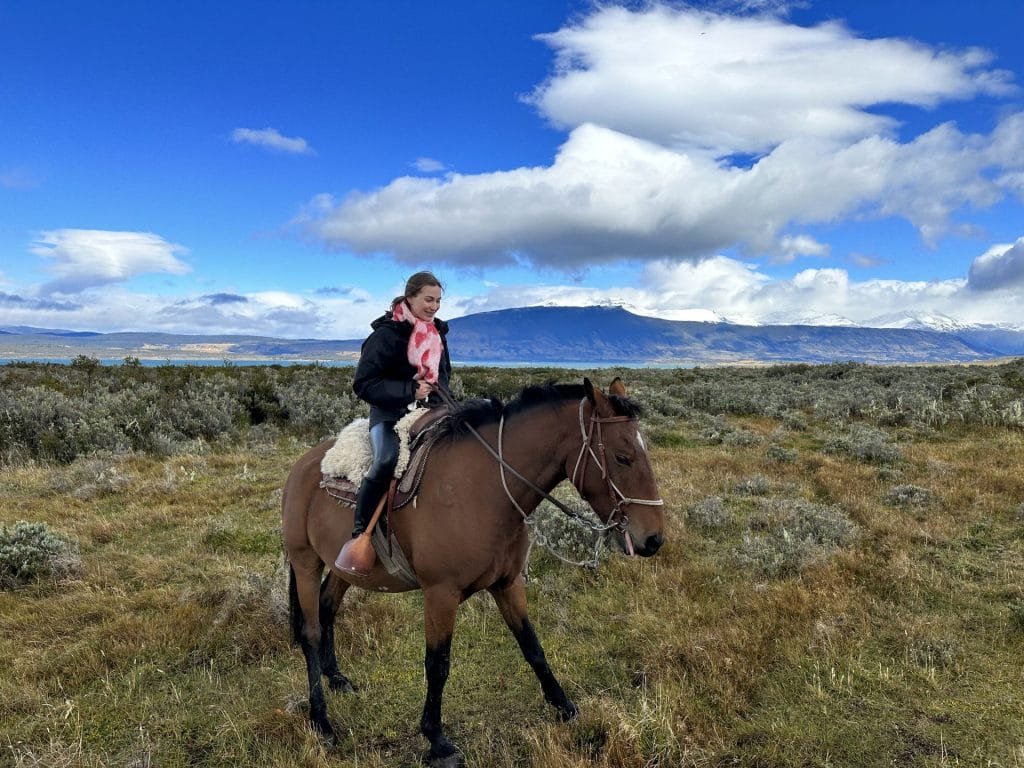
[0,0,1024,338]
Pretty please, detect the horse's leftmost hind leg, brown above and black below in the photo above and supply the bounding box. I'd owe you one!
[289,554,334,741]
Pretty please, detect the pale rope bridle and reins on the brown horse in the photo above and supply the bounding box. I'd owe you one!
[435,385,665,565]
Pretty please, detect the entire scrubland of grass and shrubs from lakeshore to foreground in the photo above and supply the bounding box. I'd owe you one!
[0,358,1024,768]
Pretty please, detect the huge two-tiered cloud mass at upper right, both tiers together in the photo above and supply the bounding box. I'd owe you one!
[301,5,1024,273]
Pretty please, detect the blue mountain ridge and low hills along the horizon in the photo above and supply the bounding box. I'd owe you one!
[0,305,1024,366]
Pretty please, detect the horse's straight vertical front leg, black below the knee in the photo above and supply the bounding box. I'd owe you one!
[420,587,464,768]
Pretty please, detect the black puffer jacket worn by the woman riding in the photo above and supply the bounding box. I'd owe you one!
[352,312,452,426]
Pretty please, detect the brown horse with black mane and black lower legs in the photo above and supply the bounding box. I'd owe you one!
[283,379,665,766]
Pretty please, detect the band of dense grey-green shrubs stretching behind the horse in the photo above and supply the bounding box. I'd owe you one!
[0,357,1024,465]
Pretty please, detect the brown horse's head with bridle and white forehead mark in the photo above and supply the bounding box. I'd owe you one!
[566,378,665,557]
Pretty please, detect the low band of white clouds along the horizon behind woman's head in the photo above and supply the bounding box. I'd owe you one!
[0,238,1024,339]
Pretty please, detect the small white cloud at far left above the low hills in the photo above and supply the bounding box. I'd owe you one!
[30,229,191,295]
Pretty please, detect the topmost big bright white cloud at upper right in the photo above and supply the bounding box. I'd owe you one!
[530,5,1011,156]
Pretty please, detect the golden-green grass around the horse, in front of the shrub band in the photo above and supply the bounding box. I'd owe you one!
[0,364,1024,768]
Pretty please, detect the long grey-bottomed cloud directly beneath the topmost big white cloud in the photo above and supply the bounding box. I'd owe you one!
[304,116,1024,270]
